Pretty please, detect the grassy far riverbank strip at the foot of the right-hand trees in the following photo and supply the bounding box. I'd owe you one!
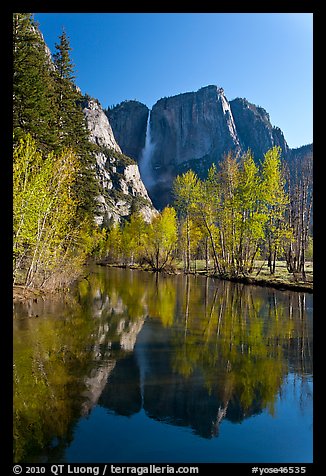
[97,260,313,293]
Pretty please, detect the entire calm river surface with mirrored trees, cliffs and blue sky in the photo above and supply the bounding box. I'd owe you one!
[14,266,313,463]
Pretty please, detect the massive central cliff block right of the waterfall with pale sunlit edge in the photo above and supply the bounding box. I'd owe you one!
[151,86,241,207]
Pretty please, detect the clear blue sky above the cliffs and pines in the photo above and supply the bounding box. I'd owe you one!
[34,13,313,147]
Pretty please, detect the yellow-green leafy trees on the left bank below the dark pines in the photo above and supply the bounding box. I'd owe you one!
[13,135,101,287]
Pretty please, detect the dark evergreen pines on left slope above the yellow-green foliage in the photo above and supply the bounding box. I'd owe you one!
[13,13,98,221]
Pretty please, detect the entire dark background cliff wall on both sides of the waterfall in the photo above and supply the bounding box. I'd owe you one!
[110,85,310,208]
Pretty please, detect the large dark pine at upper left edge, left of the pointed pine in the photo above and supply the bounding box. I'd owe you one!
[13,13,56,150]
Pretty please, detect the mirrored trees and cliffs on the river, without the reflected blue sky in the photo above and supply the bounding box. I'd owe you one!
[14,267,312,462]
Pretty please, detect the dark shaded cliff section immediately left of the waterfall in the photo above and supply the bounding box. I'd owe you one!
[107,101,149,160]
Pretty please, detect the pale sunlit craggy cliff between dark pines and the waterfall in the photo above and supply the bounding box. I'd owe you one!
[83,99,156,225]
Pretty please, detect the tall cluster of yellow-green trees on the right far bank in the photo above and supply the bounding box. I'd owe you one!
[174,147,298,276]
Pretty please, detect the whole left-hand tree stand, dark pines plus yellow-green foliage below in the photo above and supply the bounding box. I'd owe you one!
[13,17,103,287]
